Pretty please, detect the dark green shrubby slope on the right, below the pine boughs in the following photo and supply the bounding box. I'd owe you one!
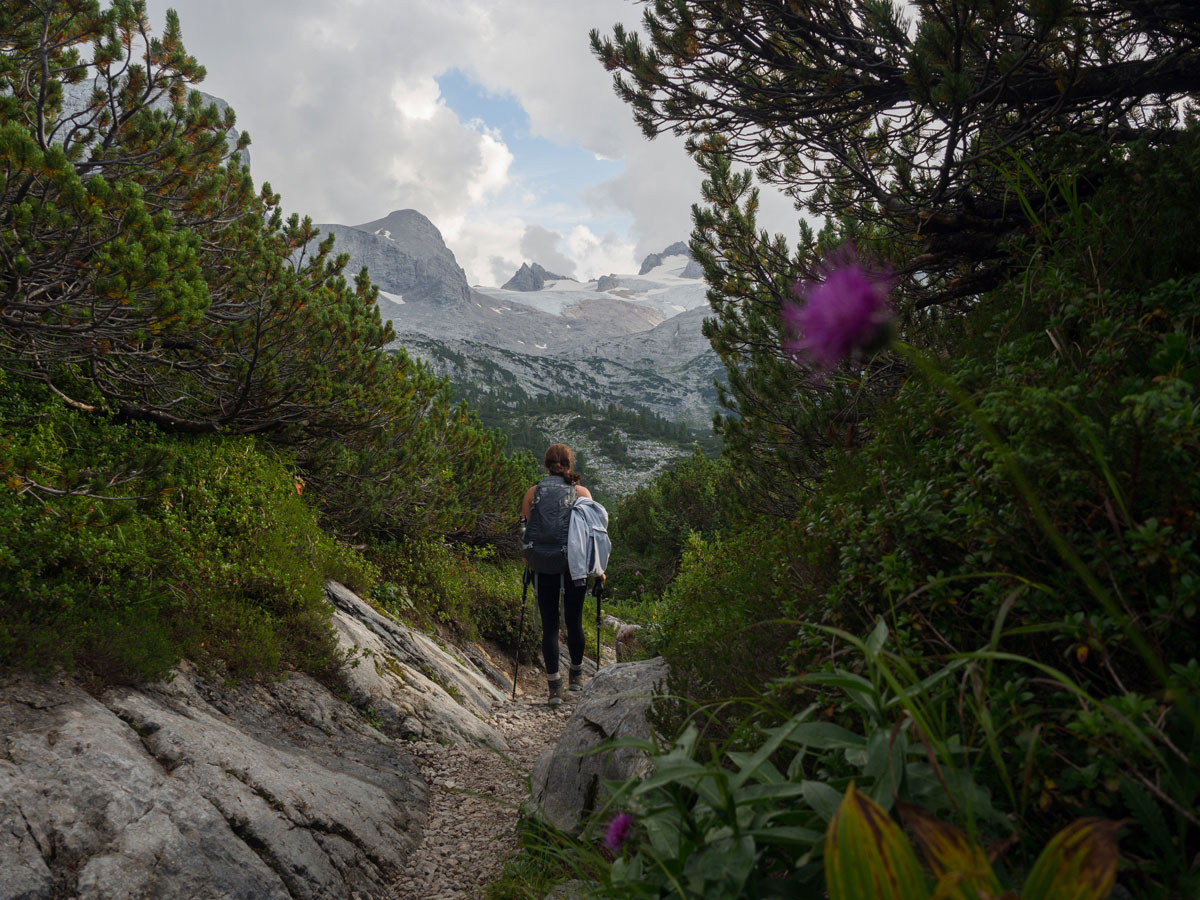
[590,148,1200,896]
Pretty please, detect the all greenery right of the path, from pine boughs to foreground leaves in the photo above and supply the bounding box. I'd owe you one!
[472,0,1200,900]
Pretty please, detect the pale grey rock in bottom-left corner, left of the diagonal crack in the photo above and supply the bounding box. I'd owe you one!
[0,678,289,900]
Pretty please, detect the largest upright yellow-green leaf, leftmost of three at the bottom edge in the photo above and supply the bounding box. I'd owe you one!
[824,785,930,900]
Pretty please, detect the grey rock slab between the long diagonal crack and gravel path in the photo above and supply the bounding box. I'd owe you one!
[103,671,427,899]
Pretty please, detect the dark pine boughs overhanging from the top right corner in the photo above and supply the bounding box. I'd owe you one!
[592,0,1200,304]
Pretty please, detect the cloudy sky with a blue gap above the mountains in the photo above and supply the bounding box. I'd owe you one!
[138,0,796,284]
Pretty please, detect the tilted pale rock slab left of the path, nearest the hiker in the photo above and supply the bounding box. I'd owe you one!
[325,582,506,750]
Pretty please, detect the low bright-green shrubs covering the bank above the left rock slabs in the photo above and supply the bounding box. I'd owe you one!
[0,384,372,680]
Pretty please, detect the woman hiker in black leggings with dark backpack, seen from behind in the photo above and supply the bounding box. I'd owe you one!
[521,444,602,707]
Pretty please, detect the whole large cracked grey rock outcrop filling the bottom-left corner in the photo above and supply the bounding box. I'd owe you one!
[0,667,427,900]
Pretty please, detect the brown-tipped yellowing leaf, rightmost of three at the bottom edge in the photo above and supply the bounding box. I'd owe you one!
[1021,818,1121,900]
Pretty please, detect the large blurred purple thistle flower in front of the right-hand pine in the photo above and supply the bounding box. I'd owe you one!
[782,245,892,371]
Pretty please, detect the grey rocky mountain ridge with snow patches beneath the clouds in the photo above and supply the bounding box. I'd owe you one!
[319,210,724,427]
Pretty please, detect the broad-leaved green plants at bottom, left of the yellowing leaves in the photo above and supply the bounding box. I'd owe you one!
[586,623,1012,900]
